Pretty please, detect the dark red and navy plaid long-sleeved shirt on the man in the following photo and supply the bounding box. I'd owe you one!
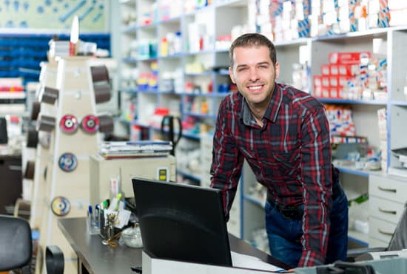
[211,83,332,266]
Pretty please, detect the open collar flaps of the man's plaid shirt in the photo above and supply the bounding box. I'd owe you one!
[240,83,283,126]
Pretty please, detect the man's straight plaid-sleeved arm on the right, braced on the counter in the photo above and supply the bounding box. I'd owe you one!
[299,107,332,266]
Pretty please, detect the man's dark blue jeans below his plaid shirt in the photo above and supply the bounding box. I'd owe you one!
[265,191,348,267]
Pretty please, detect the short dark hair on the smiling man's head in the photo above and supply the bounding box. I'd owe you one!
[229,33,277,67]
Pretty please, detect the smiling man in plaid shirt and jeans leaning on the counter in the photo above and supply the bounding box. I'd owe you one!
[211,33,348,267]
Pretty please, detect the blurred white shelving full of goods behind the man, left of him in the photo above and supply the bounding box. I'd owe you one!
[115,0,254,184]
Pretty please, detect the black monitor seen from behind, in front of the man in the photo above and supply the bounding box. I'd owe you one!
[132,178,232,266]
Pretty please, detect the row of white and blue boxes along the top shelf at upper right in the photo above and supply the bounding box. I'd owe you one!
[256,0,392,41]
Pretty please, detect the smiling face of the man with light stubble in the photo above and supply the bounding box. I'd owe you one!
[229,46,280,108]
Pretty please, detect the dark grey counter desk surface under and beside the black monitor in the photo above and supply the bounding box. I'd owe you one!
[58,218,287,274]
